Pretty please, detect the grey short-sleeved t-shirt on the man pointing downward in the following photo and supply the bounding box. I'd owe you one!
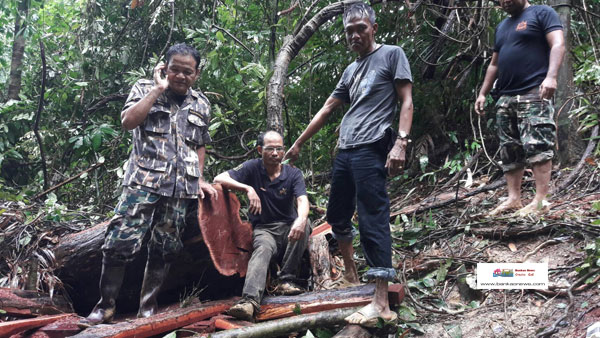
[331,45,412,149]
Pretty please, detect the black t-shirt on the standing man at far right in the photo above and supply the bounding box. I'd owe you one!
[494,5,562,95]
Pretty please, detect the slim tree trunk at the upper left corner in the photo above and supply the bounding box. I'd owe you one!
[7,0,29,100]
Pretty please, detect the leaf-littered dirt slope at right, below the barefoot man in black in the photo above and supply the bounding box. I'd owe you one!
[382,159,600,338]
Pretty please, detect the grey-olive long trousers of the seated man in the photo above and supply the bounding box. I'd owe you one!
[242,222,311,307]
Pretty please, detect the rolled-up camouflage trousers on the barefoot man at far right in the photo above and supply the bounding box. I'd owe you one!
[496,93,556,172]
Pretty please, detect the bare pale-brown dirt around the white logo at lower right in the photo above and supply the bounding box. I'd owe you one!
[412,238,600,338]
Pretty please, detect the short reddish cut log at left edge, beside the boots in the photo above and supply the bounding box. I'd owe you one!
[0,288,73,317]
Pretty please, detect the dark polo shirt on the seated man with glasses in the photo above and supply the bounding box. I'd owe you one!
[228,159,306,226]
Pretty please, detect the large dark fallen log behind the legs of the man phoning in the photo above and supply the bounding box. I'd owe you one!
[53,188,251,315]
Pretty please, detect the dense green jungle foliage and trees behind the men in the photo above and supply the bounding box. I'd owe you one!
[0,0,600,337]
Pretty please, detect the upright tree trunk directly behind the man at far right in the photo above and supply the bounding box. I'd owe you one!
[548,0,584,164]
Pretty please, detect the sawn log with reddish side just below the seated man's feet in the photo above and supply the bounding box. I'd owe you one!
[256,284,404,321]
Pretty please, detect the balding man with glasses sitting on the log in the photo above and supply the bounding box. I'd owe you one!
[214,131,311,320]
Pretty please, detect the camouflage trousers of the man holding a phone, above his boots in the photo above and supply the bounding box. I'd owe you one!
[102,187,190,265]
